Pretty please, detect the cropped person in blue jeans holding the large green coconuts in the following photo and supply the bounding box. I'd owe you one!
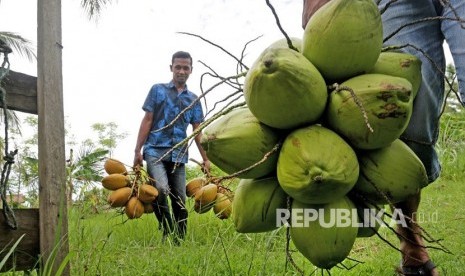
[302,0,465,275]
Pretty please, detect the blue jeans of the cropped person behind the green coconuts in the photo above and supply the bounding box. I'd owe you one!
[379,0,465,183]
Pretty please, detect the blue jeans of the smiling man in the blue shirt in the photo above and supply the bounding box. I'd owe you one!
[145,156,188,238]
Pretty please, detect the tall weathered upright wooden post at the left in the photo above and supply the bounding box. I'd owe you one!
[37,0,69,275]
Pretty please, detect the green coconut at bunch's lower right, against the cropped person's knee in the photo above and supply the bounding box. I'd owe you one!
[353,139,428,204]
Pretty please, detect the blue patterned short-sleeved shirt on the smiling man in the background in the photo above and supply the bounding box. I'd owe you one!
[142,81,203,163]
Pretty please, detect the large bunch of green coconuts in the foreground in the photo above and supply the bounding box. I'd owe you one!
[201,0,428,269]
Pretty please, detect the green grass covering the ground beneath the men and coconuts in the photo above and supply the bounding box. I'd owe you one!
[62,176,465,275]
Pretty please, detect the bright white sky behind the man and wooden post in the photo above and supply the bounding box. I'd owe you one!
[0,0,303,164]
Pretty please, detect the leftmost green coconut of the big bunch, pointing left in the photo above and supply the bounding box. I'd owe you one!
[201,108,279,178]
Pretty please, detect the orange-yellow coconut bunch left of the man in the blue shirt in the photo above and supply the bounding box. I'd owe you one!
[102,158,158,219]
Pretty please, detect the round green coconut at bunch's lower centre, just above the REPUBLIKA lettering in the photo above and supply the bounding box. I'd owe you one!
[277,125,359,204]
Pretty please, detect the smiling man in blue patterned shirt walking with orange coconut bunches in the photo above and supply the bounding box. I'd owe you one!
[134,51,210,243]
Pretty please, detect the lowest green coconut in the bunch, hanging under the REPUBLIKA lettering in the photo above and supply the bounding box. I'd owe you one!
[290,197,358,269]
